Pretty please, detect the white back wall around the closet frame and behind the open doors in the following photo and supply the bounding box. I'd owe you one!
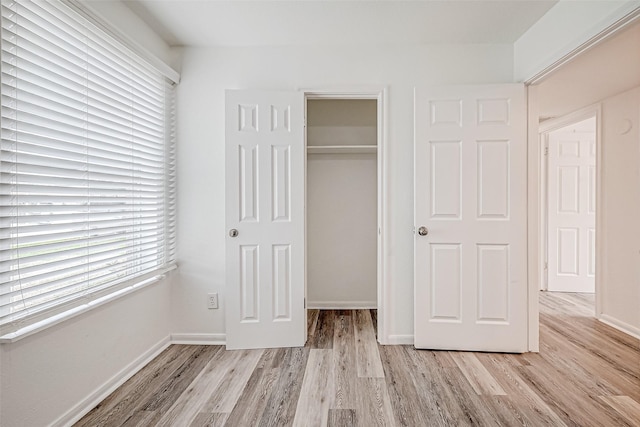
[172,45,513,342]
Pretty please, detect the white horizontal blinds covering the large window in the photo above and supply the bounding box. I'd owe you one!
[0,0,175,331]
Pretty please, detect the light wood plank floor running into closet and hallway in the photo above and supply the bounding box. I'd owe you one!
[77,293,640,427]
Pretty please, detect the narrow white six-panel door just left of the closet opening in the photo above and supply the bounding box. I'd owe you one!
[225,90,306,349]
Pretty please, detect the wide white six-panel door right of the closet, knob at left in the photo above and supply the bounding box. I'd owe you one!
[414,85,527,352]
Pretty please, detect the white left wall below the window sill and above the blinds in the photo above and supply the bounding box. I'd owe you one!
[0,2,171,427]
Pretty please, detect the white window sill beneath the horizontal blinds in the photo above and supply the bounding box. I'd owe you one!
[0,265,176,344]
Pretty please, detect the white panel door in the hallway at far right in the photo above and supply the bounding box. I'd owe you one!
[547,122,596,292]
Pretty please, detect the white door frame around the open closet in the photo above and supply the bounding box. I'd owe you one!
[302,86,391,344]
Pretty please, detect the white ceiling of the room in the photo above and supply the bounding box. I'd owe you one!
[122,0,557,46]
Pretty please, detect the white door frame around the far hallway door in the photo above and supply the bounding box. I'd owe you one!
[537,103,603,306]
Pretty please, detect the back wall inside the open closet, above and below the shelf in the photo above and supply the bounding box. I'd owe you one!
[307,99,378,308]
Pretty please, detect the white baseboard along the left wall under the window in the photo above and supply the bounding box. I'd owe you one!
[51,337,171,426]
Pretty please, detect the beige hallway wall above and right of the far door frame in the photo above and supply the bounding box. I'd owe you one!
[537,17,640,335]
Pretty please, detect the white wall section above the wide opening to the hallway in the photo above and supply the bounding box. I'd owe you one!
[514,0,640,81]
